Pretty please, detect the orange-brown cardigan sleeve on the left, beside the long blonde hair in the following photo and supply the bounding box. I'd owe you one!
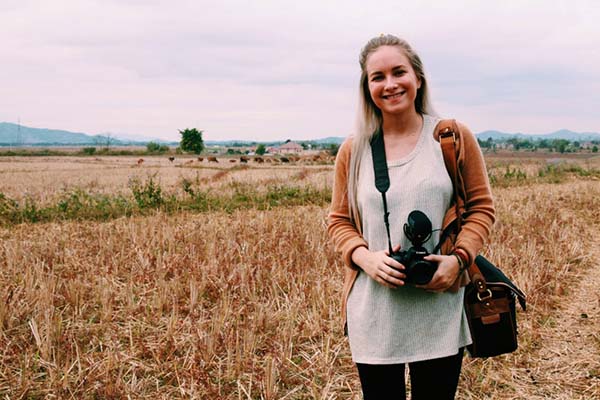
[327,138,368,269]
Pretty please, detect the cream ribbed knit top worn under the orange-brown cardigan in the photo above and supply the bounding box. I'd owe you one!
[347,115,471,364]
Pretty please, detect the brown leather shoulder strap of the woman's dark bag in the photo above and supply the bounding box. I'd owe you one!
[437,119,492,300]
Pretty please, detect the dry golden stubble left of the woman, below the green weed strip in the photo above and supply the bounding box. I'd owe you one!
[0,207,351,398]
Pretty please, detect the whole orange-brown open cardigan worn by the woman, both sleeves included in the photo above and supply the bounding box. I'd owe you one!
[327,123,495,322]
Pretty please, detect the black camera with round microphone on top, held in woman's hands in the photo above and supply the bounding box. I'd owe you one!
[390,210,437,285]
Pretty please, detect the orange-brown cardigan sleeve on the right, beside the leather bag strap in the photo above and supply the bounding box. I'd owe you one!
[455,124,495,263]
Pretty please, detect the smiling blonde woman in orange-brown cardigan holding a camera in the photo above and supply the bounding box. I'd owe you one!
[328,35,494,399]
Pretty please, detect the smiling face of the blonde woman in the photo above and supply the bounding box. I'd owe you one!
[366,46,421,117]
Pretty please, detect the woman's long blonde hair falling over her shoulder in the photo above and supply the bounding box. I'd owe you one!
[348,35,435,227]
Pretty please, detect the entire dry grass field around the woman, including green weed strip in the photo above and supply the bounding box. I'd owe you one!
[0,152,600,400]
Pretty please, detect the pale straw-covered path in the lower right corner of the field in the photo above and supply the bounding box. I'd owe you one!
[514,234,600,400]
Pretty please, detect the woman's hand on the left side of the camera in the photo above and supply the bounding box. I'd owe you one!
[352,245,406,289]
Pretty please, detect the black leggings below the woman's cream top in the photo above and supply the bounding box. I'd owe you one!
[356,349,464,400]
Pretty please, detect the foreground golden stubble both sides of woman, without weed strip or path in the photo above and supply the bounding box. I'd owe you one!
[0,156,600,399]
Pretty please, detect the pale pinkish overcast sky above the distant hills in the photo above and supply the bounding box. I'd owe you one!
[0,0,600,141]
